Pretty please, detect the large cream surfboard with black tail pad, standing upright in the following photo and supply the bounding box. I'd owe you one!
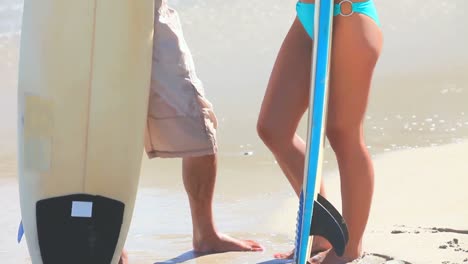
[18,0,154,264]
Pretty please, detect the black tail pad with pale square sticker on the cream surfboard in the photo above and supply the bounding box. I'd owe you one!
[36,194,125,264]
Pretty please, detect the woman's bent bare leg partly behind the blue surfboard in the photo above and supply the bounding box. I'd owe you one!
[257,16,330,258]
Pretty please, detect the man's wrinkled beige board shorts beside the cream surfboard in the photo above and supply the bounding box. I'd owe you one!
[145,0,217,158]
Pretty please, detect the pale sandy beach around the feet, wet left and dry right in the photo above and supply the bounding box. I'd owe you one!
[0,142,468,264]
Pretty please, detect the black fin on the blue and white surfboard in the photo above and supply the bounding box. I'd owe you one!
[310,194,349,256]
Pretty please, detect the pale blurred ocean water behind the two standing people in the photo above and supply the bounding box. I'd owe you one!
[0,0,468,158]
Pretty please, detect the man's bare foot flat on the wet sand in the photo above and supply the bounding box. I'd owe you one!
[193,234,263,254]
